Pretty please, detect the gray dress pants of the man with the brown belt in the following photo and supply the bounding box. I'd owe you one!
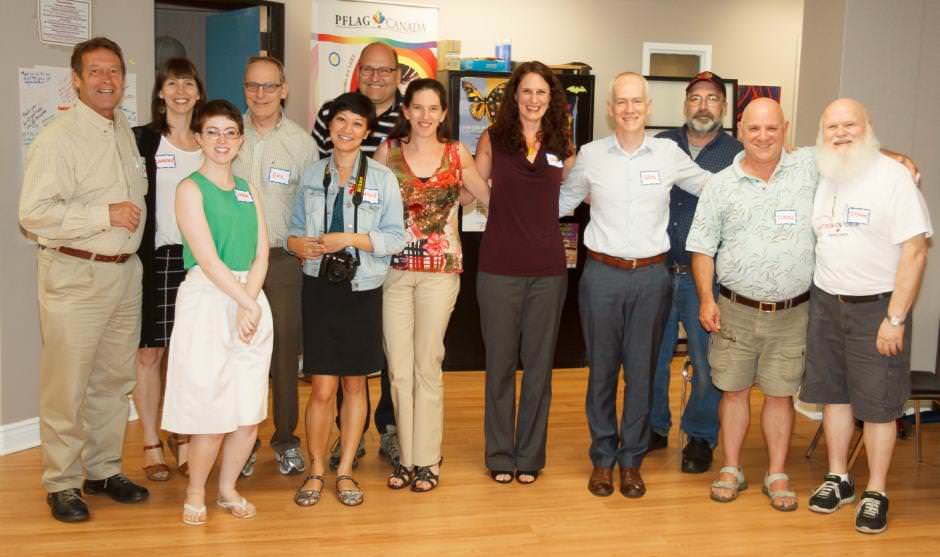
[578,259,672,468]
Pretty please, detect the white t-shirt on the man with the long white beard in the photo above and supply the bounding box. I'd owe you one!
[813,153,933,296]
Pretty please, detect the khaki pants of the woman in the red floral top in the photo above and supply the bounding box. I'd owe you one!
[382,270,460,468]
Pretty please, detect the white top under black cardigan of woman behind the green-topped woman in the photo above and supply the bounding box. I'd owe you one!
[154,136,202,248]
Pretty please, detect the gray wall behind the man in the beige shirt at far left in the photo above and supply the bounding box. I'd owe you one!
[0,0,153,424]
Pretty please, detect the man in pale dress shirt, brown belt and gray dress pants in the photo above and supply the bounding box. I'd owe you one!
[560,72,710,497]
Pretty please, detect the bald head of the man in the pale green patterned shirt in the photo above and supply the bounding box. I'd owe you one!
[738,97,788,165]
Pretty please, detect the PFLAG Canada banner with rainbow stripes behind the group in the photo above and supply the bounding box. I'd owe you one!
[307,0,437,127]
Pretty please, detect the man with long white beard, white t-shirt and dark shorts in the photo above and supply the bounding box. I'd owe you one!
[800,99,933,534]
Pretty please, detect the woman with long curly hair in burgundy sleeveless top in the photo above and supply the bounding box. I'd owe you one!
[476,58,574,484]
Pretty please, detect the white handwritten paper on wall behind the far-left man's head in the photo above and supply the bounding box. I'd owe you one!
[18,66,138,160]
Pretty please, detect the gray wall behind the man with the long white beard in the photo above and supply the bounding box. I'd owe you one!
[797,0,940,370]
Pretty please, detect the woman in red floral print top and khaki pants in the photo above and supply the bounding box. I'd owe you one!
[375,79,489,492]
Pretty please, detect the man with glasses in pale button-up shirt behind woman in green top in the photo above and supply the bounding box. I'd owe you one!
[233,56,316,477]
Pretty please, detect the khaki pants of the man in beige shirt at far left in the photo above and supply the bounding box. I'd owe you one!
[37,249,141,492]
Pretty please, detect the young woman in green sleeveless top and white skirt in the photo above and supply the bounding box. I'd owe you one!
[163,100,273,525]
